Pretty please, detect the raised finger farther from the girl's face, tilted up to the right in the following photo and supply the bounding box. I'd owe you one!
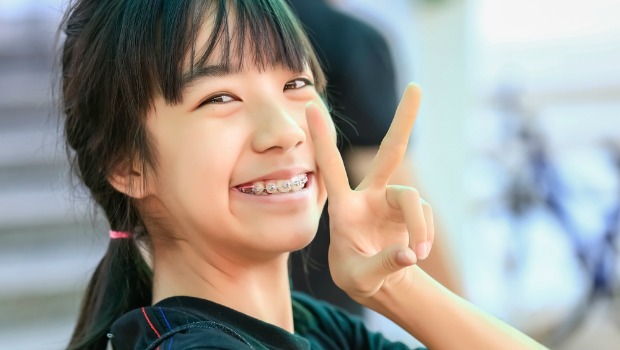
[360,83,422,188]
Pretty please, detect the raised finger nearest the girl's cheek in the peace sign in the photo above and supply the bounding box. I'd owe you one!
[306,102,351,200]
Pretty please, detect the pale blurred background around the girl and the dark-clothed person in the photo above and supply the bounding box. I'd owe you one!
[0,0,620,349]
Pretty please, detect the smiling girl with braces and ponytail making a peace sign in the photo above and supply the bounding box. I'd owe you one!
[61,0,539,349]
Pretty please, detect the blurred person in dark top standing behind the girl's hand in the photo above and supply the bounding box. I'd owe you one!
[288,0,462,314]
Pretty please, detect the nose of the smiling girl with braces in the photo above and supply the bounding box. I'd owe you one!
[252,107,306,152]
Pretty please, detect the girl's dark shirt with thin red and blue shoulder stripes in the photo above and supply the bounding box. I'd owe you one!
[111,292,422,350]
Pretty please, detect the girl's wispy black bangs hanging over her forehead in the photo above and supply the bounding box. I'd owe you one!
[158,0,326,103]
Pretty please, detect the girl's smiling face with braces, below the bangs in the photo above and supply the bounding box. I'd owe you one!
[146,55,335,257]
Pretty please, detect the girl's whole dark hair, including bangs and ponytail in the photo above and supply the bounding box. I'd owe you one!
[60,0,325,349]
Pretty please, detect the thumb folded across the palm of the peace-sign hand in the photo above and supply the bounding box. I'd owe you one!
[365,246,417,279]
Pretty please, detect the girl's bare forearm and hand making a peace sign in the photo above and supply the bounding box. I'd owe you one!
[307,84,544,349]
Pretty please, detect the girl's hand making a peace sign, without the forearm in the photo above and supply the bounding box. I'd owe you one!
[306,84,434,301]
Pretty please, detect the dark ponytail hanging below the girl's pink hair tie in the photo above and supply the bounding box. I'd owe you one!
[68,239,153,350]
